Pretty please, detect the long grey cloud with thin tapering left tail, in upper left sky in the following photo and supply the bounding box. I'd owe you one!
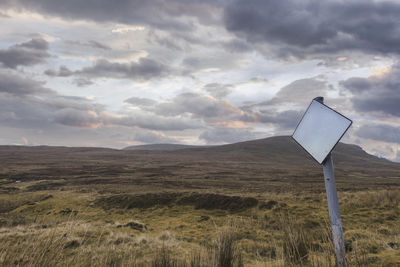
[44,58,173,80]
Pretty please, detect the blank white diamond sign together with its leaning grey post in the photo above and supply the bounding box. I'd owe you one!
[292,97,352,267]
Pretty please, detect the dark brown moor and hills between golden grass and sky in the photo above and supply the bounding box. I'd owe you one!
[0,136,400,192]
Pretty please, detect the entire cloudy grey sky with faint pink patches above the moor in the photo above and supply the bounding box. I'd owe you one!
[0,0,400,161]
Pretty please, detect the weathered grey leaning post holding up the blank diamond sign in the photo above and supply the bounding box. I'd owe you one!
[314,96,347,267]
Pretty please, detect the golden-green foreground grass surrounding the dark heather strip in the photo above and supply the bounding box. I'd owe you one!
[0,187,400,266]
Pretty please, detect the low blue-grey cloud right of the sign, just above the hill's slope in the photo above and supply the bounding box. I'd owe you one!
[355,125,400,143]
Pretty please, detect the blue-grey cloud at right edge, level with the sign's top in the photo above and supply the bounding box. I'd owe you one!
[341,64,400,116]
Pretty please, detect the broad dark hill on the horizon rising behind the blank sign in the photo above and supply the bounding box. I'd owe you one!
[124,136,400,172]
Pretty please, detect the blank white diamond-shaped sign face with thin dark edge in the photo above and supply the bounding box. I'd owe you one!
[292,100,352,164]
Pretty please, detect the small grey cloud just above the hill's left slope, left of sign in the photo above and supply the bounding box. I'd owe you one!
[199,127,257,144]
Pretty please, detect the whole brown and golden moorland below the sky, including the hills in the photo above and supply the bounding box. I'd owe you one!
[0,138,400,266]
